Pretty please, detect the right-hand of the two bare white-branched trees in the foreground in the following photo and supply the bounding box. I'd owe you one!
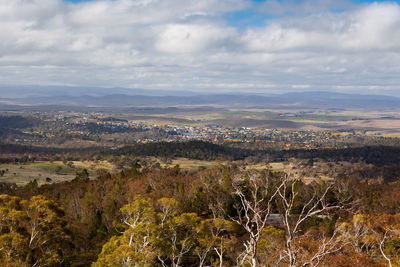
[278,180,346,267]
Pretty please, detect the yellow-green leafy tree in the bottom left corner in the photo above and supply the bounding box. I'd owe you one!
[0,195,71,266]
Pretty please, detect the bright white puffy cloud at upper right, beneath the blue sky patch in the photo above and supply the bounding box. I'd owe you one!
[243,3,400,53]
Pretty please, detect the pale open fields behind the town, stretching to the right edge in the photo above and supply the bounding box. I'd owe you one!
[111,108,400,133]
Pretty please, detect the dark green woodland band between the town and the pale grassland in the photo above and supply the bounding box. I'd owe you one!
[0,141,400,165]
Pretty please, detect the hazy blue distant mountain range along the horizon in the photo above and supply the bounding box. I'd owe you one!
[0,86,400,110]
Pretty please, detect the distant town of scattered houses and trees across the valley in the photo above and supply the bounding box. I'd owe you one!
[3,112,400,149]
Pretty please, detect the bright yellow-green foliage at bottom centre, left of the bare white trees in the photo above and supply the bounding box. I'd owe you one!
[93,196,231,267]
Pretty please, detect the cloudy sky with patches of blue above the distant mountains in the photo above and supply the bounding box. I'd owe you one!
[0,0,400,95]
